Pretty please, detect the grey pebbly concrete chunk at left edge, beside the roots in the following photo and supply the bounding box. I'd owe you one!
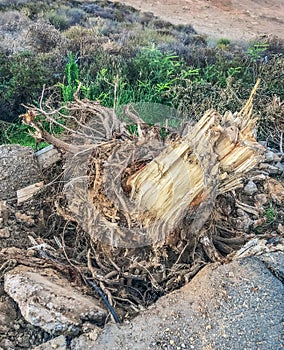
[0,145,41,200]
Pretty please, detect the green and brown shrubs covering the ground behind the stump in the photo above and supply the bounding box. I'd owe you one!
[0,1,284,146]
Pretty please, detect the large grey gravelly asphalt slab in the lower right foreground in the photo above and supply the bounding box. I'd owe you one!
[69,252,284,350]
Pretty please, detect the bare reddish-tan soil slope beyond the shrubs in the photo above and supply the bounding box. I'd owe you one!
[111,0,284,41]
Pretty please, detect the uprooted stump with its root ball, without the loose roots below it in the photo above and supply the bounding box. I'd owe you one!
[22,81,264,260]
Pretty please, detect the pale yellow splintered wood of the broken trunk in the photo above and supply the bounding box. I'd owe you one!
[128,82,264,229]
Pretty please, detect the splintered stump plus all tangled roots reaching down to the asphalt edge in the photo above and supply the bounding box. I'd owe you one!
[17,82,272,322]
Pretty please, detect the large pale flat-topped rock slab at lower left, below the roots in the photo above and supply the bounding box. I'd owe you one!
[4,265,106,335]
